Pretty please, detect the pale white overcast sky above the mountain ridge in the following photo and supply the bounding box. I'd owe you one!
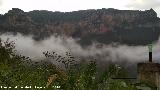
[0,0,160,16]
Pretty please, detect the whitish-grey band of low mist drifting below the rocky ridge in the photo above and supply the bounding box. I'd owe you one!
[0,34,160,62]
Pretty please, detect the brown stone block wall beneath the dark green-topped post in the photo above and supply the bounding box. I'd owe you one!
[137,63,160,90]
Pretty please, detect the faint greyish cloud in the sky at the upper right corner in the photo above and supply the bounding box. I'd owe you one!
[127,0,160,9]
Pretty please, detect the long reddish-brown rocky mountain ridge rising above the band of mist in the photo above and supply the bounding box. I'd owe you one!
[0,8,160,45]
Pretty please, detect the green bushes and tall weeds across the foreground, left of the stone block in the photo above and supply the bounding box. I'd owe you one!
[0,40,155,90]
